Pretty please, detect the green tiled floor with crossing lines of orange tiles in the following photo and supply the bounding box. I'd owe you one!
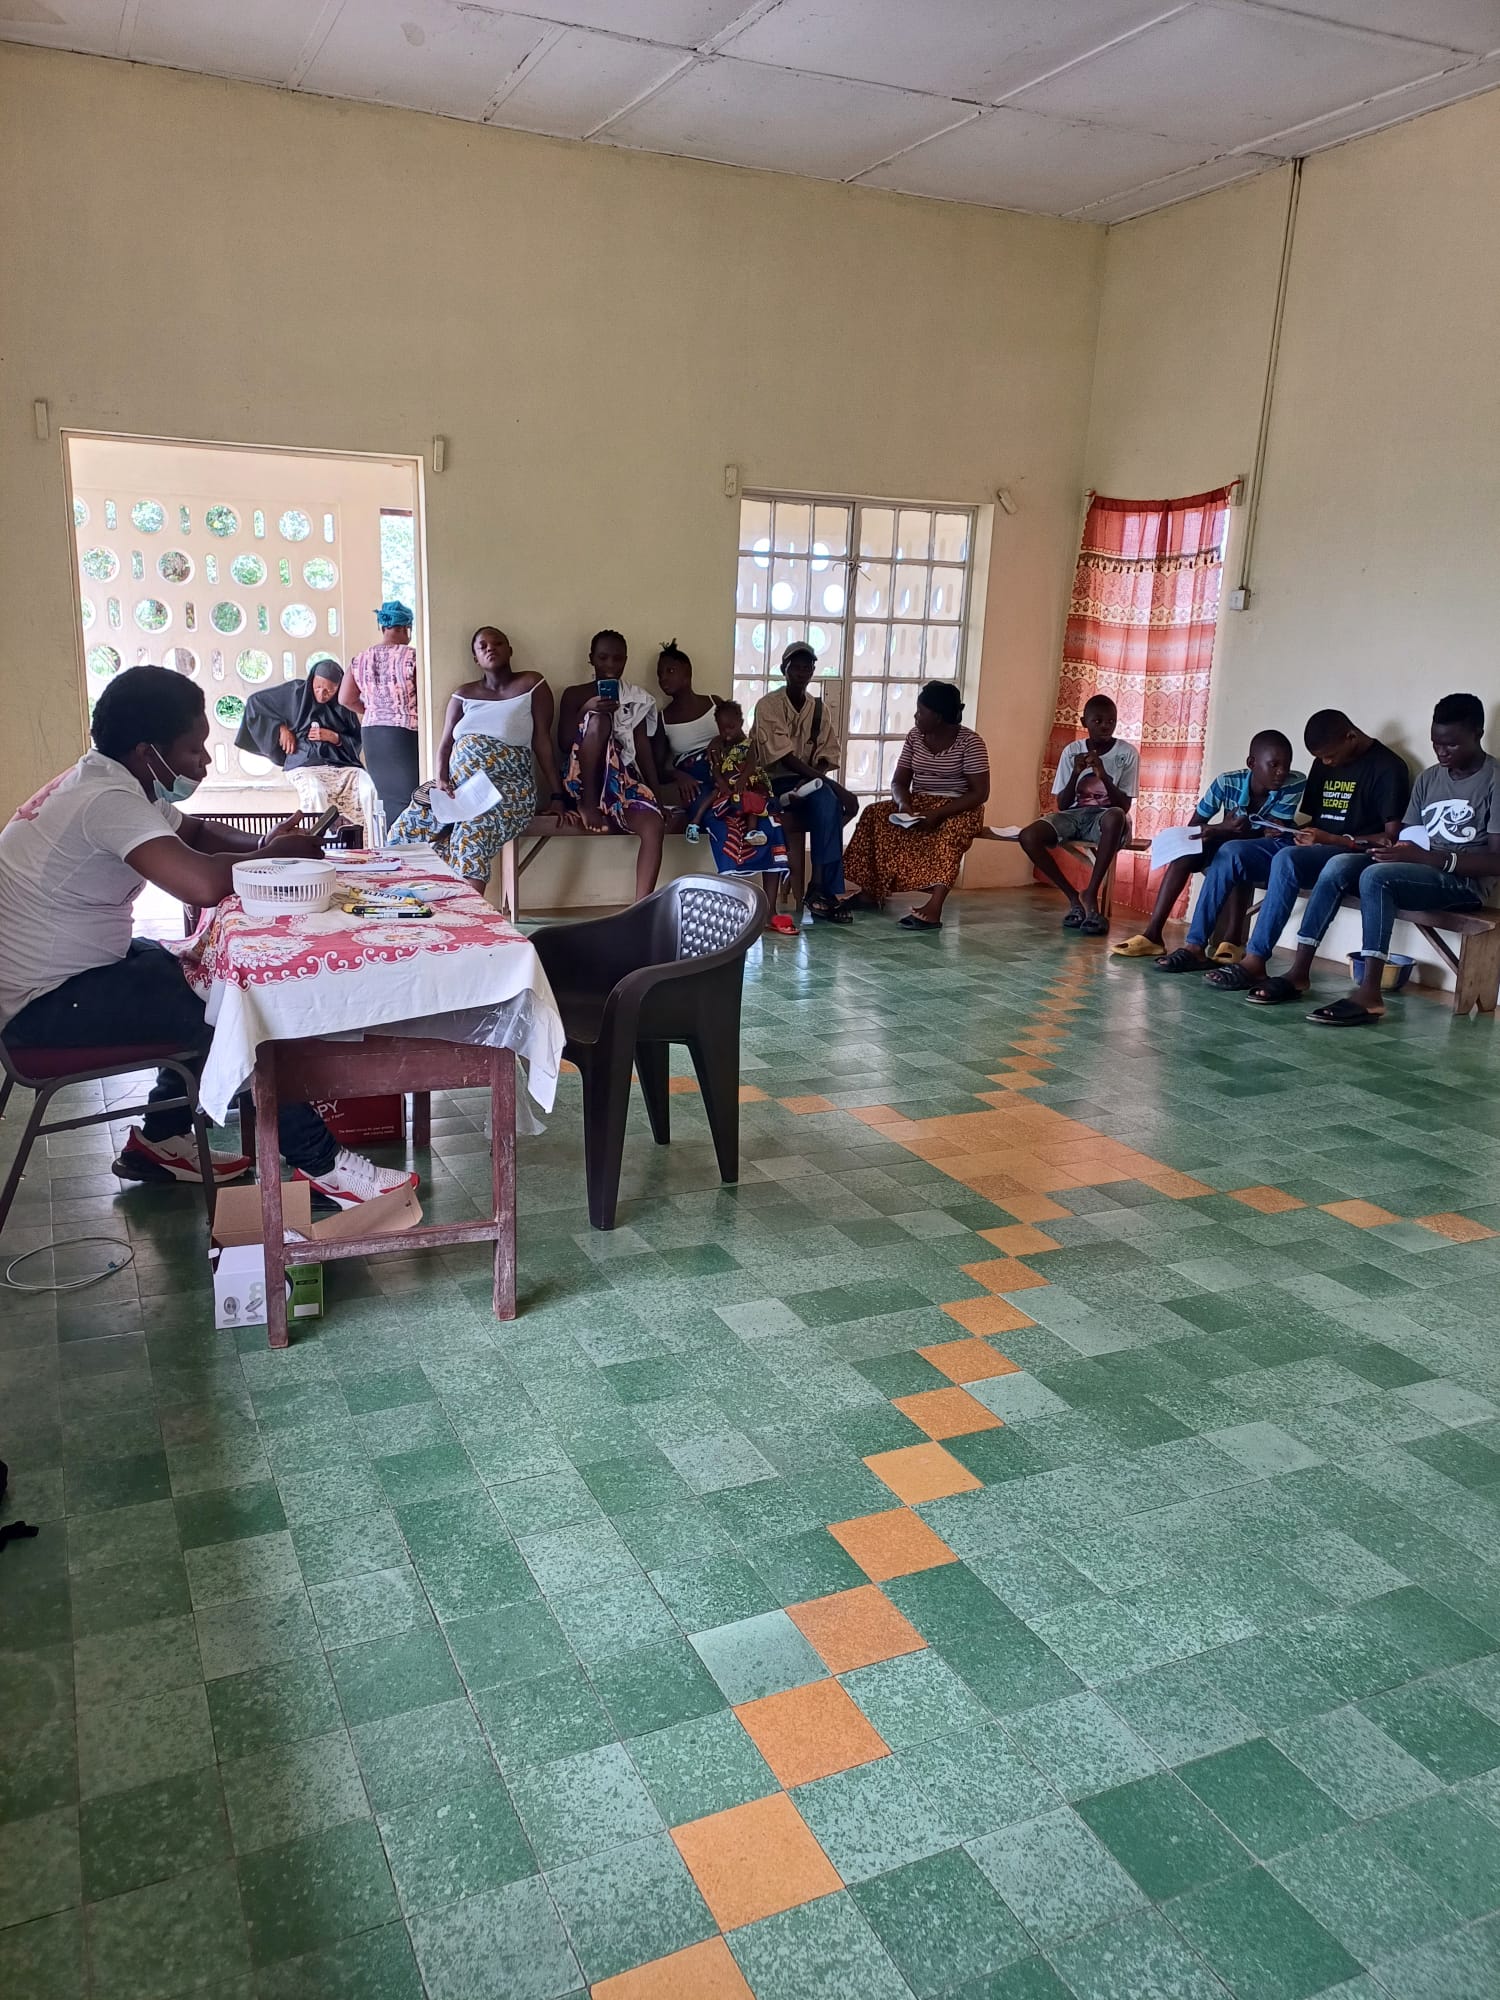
[0,896,1500,2000]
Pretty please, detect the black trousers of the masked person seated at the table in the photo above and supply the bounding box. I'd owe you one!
[6,938,338,1174]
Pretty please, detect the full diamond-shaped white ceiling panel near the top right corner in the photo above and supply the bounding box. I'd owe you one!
[1016,4,1472,152]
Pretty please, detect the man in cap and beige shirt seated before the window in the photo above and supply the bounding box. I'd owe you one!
[754,640,860,924]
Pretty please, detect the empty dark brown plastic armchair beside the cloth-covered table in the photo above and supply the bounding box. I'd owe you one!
[532,876,768,1230]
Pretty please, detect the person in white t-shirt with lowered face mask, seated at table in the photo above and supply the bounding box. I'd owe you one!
[0,666,416,1208]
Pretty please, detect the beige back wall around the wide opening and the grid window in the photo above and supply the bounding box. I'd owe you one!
[0,48,1104,902]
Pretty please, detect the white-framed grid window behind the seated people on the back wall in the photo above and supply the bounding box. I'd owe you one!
[734,494,974,824]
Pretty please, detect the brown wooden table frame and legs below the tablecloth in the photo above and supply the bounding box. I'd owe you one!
[254,1034,516,1348]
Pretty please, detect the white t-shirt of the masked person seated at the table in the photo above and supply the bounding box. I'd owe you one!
[0,750,182,1026]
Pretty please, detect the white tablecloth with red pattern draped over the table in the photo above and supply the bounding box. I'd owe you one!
[182,850,564,1122]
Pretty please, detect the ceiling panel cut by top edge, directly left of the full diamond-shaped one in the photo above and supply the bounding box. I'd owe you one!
[722,0,1186,104]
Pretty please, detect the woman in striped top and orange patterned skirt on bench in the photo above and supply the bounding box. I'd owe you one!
[844,680,990,930]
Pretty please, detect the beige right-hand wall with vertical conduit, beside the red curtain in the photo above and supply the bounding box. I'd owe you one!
[1086,92,1500,980]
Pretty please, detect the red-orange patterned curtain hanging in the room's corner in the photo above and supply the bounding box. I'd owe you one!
[1042,486,1232,910]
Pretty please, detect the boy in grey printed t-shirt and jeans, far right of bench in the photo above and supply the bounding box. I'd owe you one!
[1308,694,1500,1028]
